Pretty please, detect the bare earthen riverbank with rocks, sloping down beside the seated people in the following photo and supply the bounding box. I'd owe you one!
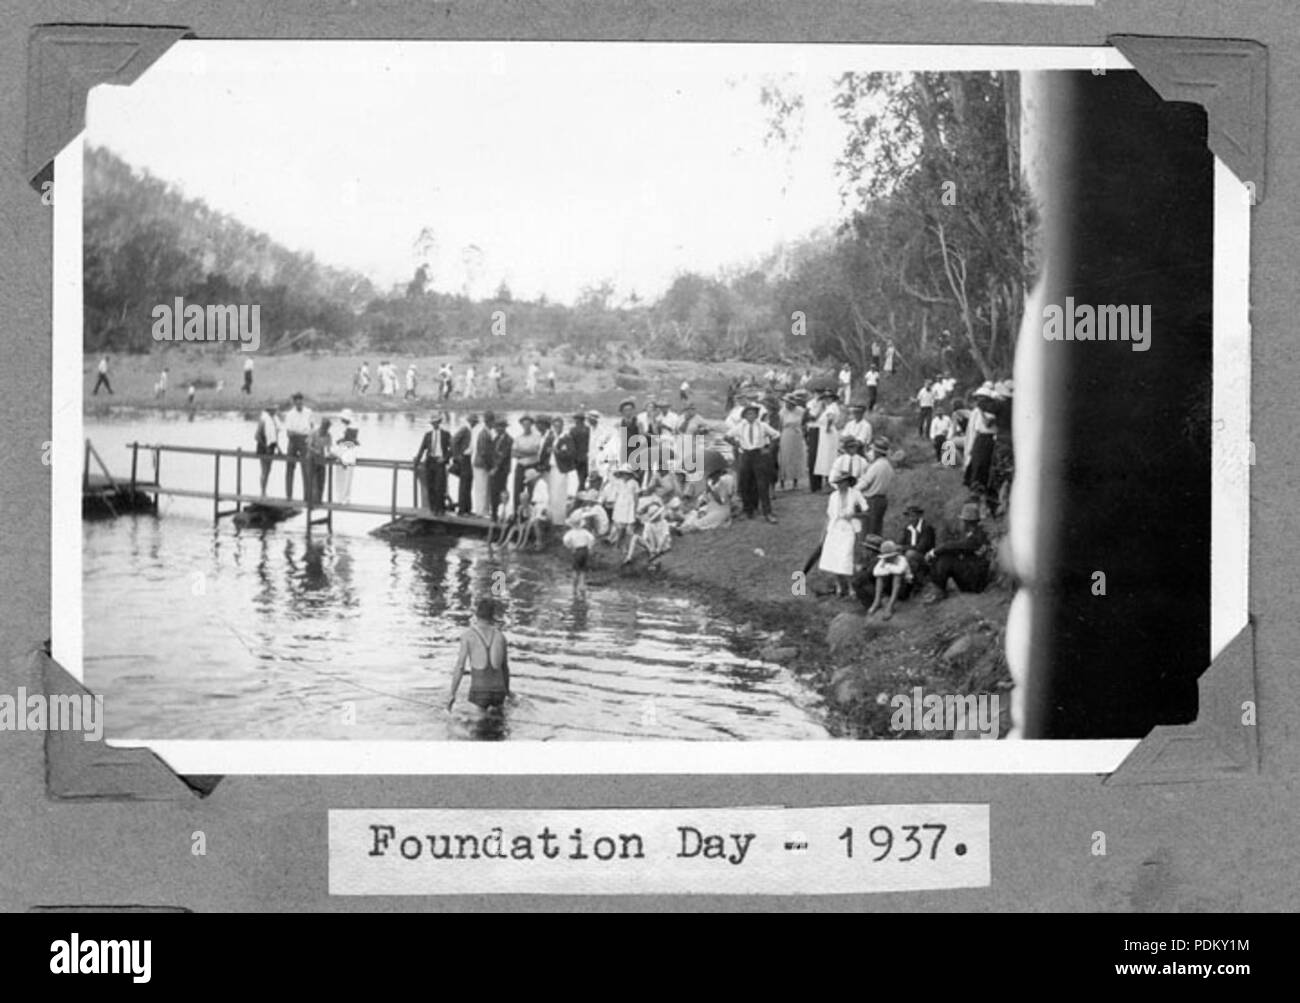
[629,426,1011,738]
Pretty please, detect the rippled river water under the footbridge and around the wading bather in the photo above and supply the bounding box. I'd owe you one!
[82,412,828,741]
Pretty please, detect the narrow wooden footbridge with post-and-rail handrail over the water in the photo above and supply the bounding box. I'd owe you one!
[82,439,504,539]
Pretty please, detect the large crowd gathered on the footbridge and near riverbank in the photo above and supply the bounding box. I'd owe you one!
[245,364,1014,602]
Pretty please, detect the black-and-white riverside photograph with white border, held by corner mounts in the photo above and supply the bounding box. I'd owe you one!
[53,40,1249,772]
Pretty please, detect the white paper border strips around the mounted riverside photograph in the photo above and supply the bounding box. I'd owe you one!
[51,42,1253,774]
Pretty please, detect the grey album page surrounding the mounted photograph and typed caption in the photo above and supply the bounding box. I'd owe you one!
[0,0,1300,911]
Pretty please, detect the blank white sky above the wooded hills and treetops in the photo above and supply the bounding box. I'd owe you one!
[86,40,874,303]
